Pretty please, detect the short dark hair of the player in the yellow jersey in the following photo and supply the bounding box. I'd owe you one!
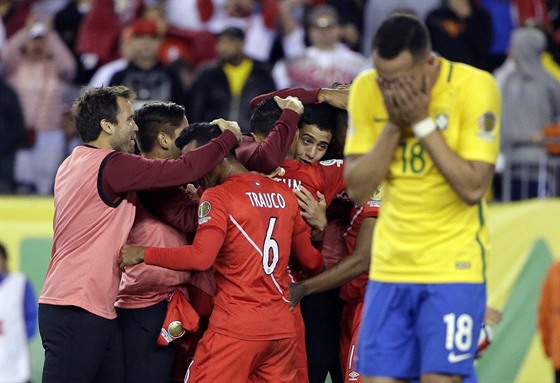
[372,13,432,62]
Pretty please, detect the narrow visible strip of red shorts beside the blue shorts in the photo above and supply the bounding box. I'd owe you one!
[340,301,364,383]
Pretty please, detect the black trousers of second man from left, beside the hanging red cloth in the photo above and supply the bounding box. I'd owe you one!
[117,300,175,383]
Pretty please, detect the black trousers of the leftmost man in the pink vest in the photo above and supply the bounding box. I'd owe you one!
[39,304,124,383]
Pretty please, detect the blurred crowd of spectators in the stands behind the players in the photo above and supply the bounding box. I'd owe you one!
[0,0,560,200]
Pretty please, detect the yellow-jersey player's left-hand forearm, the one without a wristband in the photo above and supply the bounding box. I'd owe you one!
[344,123,400,204]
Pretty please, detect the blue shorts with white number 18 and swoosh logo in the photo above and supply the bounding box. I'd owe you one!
[357,281,486,379]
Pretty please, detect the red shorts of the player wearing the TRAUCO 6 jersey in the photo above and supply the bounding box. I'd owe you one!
[185,329,296,383]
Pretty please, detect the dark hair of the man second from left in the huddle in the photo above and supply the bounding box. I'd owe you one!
[134,101,185,153]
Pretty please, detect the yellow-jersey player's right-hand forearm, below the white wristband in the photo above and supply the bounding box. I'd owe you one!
[421,131,494,205]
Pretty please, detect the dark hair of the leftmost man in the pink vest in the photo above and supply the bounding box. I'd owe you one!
[72,85,136,143]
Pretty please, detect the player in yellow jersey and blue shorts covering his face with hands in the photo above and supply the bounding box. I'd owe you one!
[345,15,500,383]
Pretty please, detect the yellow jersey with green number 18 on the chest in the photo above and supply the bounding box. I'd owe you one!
[344,59,501,283]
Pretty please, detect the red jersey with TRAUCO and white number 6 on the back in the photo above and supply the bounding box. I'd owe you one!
[145,173,322,340]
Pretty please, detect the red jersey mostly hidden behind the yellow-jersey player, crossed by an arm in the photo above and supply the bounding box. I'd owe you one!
[340,194,381,303]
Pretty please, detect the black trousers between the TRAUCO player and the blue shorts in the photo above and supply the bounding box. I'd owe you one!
[301,289,344,383]
